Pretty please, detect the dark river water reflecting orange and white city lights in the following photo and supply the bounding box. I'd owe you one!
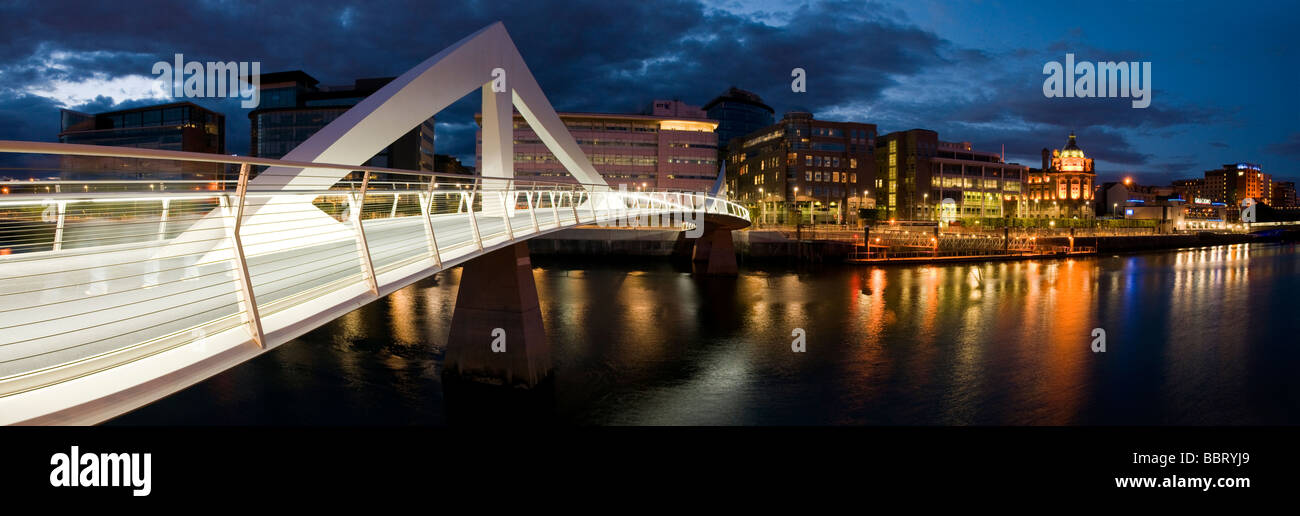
[111,244,1300,425]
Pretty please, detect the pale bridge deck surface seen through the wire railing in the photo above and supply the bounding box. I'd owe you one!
[0,206,595,378]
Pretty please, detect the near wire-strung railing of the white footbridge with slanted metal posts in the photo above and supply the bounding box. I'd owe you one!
[0,142,749,396]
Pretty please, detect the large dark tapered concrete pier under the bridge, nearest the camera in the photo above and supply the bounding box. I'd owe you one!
[443,243,551,389]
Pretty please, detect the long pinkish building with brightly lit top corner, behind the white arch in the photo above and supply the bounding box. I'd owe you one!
[475,100,719,192]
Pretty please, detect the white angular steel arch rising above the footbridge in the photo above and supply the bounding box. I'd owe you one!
[157,22,612,256]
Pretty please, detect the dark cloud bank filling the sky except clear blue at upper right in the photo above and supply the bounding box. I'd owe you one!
[0,0,1268,176]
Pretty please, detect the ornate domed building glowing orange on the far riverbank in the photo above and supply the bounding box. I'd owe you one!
[1026,133,1097,218]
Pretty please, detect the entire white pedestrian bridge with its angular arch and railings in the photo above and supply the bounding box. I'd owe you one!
[0,23,749,424]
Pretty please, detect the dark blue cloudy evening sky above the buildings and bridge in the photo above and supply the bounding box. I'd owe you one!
[0,0,1300,183]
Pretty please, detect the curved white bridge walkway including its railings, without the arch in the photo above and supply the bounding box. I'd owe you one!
[0,142,749,424]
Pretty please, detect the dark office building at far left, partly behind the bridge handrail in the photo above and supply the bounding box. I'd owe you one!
[59,103,226,181]
